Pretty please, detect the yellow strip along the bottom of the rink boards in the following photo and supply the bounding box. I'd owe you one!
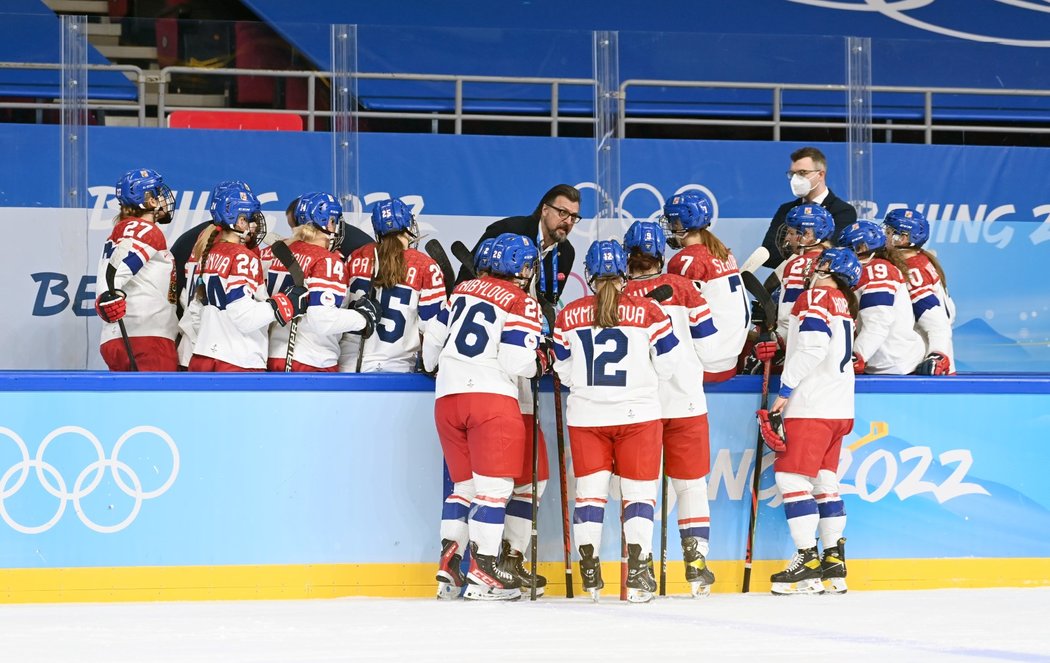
[0,558,1050,603]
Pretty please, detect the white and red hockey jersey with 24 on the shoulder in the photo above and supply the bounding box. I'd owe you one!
[193,242,274,369]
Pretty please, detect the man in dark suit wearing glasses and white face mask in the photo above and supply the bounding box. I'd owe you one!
[762,147,857,268]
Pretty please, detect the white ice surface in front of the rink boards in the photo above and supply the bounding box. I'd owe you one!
[0,587,1050,663]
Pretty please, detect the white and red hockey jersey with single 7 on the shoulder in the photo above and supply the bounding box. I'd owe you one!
[667,244,751,373]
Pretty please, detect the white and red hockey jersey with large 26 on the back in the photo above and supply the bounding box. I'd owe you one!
[423,276,541,400]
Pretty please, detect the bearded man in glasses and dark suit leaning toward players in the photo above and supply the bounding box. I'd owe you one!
[456,184,580,305]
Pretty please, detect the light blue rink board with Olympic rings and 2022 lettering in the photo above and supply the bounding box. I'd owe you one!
[0,373,1050,568]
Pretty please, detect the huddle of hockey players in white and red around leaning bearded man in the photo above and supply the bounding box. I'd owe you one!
[96,169,954,602]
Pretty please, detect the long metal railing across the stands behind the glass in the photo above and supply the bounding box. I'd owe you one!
[0,62,1050,144]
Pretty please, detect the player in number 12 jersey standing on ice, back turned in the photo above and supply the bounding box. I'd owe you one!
[554,240,678,603]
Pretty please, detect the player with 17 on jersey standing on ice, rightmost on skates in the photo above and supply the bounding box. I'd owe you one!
[758,248,861,595]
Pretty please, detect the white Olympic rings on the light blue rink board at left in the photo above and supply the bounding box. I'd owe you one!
[0,426,179,534]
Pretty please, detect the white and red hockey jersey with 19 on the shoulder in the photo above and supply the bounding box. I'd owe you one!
[854,257,926,375]
